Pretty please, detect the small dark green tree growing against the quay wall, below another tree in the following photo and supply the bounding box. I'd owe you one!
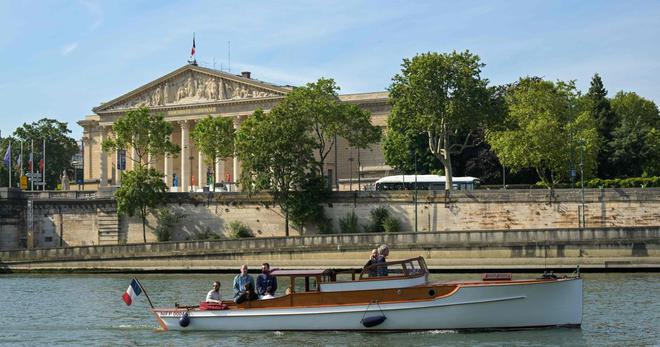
[115,167,167,243]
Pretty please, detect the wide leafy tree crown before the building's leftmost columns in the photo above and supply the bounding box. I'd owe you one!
[101,107,180,167]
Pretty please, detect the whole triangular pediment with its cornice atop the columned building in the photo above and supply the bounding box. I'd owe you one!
[94,65,290,113]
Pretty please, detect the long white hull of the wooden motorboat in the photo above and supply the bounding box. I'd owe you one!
[154,279,582,331]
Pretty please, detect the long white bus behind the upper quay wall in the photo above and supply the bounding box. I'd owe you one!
[376,175,480,190]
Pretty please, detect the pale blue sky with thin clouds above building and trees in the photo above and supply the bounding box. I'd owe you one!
[0,0,660,139]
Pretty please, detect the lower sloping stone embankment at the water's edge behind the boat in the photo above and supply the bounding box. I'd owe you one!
[0,227,660,272]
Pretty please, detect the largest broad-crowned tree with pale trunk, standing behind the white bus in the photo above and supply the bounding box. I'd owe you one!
[384,51,497,190]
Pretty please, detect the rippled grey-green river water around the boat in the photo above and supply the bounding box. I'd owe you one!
[0,273,660,347]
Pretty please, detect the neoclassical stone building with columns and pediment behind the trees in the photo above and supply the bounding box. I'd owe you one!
[78,64,391,191]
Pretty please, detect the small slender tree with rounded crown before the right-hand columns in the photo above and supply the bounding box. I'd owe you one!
[191,116,235,185]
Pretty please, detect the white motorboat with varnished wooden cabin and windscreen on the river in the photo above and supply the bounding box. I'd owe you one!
[151,257,582,331]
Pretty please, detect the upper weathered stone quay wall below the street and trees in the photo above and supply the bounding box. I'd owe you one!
[0,188,660,250]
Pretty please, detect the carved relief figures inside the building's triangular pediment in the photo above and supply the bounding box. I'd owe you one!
[108,71,282,110]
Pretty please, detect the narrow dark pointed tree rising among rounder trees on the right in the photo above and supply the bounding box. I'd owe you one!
[585,74,617,178]
